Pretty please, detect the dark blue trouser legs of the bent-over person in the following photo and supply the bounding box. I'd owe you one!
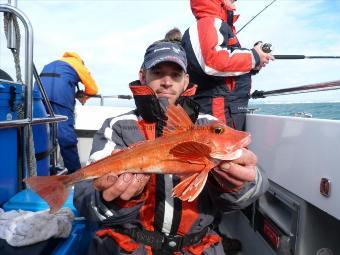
[51,102,81,173]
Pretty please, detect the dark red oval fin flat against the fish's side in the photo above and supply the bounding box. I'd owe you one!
[170,142,211,159]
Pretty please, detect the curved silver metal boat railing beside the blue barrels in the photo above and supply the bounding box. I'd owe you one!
[0,1,67,176]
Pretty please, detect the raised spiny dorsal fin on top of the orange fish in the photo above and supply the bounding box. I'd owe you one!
[163,105,193,136]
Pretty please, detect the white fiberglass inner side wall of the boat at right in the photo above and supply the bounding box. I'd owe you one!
[247,114,340,219]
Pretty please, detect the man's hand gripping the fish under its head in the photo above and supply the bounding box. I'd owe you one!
[212,149,257,190]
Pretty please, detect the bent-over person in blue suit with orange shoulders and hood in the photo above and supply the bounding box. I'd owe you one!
[40,52,98,173]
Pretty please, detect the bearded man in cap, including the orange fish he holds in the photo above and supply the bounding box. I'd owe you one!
[26,41,267,255]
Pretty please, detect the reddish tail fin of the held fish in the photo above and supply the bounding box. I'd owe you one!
[24,175,72,213]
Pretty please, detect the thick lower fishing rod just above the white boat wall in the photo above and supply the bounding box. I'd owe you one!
[250,80,340,99]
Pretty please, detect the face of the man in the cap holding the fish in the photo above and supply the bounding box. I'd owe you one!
[139,62,189,104]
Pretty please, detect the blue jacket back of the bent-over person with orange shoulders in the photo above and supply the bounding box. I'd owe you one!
[40,60,80,111]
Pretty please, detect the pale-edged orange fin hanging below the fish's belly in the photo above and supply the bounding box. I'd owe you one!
[172,170,209,202]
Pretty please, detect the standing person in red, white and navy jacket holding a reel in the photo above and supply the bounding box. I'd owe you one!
[182,0,274,130]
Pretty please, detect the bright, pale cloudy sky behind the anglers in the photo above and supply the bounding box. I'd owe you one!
[0,0,340,102]
